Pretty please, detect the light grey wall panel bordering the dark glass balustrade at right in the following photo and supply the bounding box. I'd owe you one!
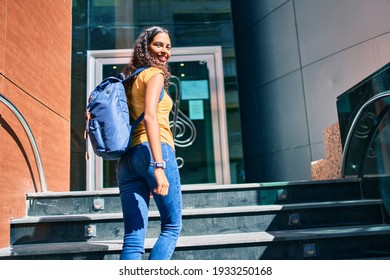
[303,34,390,147]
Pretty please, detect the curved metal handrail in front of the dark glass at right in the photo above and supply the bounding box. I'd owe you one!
[340,90,390,178]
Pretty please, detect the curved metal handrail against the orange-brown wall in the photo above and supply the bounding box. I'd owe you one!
[0,93,47,192]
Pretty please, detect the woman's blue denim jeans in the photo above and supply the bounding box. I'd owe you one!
[116,142,182,260]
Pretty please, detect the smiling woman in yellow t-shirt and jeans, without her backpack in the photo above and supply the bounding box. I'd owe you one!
[117,26,182,260]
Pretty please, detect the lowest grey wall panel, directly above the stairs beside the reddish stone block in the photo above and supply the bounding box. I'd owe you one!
[245,146,311,182]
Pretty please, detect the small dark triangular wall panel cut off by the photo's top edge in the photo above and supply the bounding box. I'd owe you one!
[231,0,288,34]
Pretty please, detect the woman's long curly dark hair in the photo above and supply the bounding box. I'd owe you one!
[123,26,171,88]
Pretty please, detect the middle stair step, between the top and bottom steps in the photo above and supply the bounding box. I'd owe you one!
[11,199,383,245]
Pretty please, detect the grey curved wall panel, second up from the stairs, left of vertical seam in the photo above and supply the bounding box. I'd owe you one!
[253,71,309,154]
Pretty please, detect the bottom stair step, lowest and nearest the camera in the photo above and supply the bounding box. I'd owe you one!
[0,224,390,260]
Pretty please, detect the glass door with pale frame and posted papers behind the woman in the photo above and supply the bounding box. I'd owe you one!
[87,47,230,190]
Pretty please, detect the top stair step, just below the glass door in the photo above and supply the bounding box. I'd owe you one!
[27,179,380,216]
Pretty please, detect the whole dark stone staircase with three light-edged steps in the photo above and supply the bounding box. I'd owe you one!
[0,179,390,260]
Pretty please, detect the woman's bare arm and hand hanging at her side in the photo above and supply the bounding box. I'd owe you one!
[143,71,169,195]
